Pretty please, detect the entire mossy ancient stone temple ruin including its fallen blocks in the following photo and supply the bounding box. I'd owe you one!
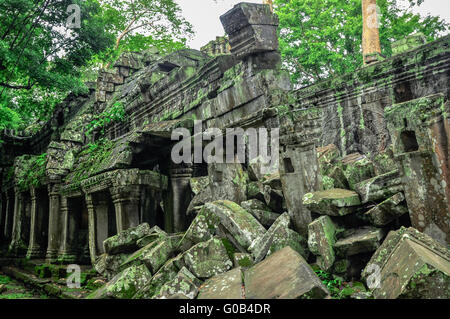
[0,3,450,298]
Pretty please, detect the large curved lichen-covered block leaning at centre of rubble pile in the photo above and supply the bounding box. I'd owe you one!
[205,201,266,249]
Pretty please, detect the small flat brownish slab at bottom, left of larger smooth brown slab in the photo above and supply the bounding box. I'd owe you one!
[197,268,243,299]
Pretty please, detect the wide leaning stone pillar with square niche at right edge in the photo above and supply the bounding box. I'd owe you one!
[385,94,450,247]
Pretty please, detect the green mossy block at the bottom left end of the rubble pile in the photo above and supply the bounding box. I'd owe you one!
[88,265,152,299]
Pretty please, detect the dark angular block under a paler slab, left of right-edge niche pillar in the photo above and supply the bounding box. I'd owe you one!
[364,193,408,227]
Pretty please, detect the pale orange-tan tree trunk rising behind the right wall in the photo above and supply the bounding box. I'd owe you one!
[362,0,381,64]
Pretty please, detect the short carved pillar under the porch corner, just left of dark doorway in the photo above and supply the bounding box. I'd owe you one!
[111,185,141,233]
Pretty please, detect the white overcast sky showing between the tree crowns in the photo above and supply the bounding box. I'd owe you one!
[175,0,450,49]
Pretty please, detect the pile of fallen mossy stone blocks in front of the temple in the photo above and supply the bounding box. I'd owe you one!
[89,145,450,299]
